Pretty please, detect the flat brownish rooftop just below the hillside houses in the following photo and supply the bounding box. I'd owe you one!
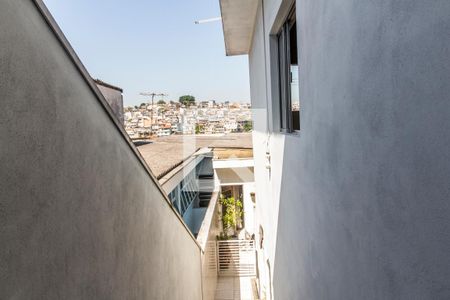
[138,133,253,179]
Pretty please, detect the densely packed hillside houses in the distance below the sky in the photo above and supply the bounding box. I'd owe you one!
[124,100,251,139]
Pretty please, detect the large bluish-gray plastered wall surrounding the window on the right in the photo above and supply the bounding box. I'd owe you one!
[250,0,450,299]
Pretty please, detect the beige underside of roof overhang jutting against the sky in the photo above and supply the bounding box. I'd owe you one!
[220,0,259,56]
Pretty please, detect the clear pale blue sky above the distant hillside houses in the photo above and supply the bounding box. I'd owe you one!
[44,0,250,105]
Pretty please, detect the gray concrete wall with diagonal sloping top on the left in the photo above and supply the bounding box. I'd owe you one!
[0,0,202,299]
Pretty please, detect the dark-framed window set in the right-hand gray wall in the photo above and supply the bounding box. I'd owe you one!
[277,7,300,132]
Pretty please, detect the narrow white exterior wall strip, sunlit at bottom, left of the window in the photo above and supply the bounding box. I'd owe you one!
[249,1,284,299]
